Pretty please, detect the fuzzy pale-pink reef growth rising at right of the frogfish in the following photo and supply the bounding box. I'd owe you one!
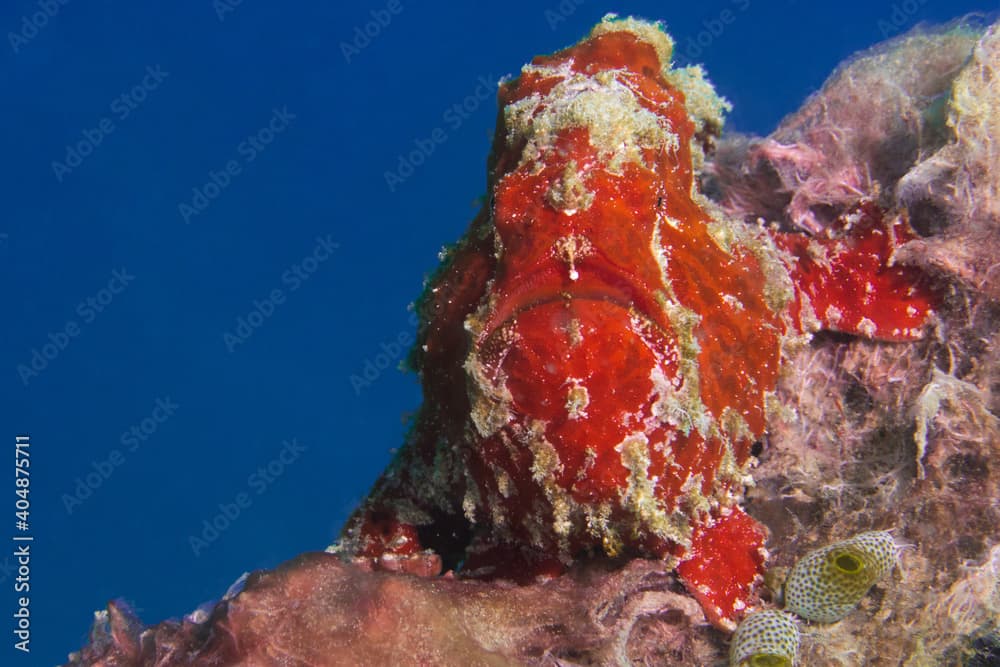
[708,18,1000,667]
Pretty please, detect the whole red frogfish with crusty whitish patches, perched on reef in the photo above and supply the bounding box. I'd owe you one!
[335,19,933,629]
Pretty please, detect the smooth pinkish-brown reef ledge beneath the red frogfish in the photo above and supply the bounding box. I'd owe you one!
[74,553,718,667]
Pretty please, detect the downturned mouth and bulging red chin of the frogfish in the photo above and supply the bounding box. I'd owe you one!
[474,256,675,442]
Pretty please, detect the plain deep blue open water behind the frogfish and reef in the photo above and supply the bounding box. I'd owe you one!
[0,0,998,665]
